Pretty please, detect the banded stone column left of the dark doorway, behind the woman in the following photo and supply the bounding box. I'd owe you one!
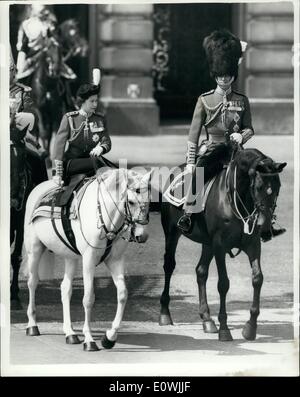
[95,4,159,134]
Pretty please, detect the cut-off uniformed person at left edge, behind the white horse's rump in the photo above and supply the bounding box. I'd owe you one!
[9,45,48,208]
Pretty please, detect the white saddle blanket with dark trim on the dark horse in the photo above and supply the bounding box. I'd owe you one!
[163,169,216,211]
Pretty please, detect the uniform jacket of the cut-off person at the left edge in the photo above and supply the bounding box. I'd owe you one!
[9,83,38,143]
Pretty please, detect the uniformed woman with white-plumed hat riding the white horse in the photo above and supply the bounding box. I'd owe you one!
[52,69,113,205]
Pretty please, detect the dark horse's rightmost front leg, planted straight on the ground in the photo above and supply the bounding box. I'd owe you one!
[242,242,264,340]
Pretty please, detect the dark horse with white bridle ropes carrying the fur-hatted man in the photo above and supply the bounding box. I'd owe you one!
[159,149,286,341]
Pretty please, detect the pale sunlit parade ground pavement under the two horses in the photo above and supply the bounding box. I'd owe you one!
[5,135,299,376]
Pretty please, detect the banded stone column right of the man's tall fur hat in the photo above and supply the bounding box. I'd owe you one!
[245,2,294,134]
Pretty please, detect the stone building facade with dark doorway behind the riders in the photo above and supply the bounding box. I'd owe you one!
[10,1,294,134]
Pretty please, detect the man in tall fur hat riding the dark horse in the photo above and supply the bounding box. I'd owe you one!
[178,29,285,241]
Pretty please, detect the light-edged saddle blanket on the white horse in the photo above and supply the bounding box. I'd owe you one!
[31,177,95,222]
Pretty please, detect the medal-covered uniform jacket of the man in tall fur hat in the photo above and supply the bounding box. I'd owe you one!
[188,87,254,145]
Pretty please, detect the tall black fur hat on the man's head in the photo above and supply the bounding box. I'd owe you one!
[203,29,242,79]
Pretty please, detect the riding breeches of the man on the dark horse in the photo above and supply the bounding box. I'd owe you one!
[183,142,228,213]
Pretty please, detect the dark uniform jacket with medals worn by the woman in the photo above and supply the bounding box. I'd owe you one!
[53,110,111,160]
